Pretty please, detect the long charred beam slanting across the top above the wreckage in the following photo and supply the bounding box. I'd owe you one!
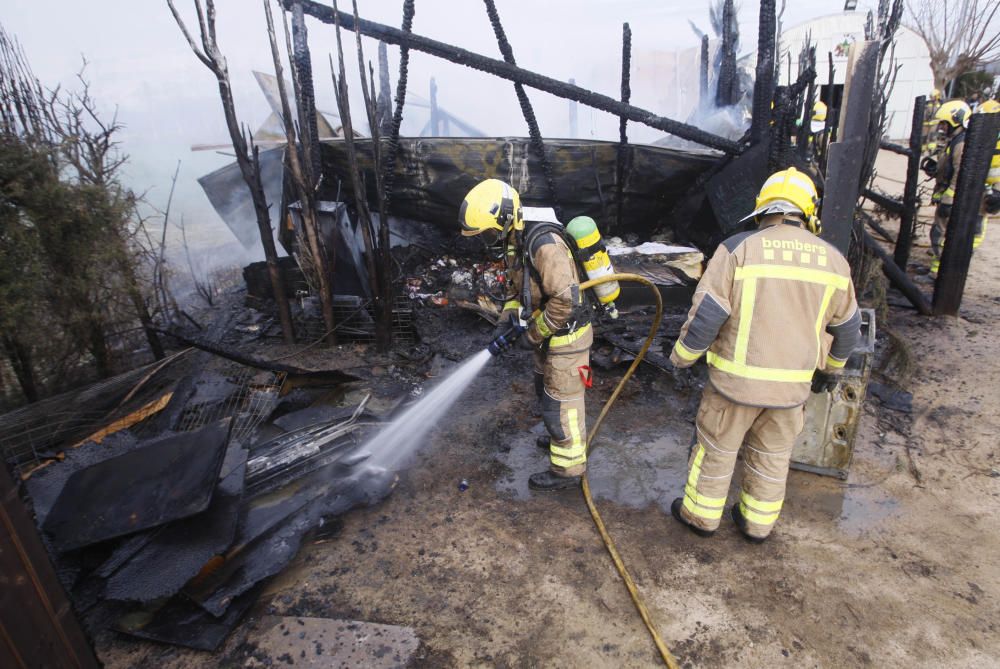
[281,0,743,154]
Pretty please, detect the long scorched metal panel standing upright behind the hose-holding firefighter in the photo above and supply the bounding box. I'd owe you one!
[316,137,719,239]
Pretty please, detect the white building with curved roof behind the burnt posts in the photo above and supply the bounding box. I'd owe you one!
[779,12,934,140]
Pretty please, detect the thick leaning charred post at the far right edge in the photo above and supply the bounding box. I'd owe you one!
[934,109,1000,316]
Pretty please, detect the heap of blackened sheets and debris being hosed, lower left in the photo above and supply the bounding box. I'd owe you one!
[9,349,395,650]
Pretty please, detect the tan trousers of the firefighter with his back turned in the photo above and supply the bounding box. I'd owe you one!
[681,383,805,537]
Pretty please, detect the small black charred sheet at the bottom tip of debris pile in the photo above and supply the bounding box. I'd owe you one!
[115,585,263,652]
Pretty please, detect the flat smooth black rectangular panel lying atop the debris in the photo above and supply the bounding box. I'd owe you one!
[43,419,230,552]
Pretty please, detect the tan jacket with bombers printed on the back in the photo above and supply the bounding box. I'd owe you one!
[670,215,861,408]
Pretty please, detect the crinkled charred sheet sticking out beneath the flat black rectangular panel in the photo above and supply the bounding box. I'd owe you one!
[105,444,247,602]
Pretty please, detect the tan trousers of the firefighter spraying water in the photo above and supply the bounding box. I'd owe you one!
[534,325,594,476]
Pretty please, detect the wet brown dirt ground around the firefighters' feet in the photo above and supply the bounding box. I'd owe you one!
[97,151,1000,669]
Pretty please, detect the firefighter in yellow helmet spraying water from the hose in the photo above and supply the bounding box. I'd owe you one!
[459,179,594,490]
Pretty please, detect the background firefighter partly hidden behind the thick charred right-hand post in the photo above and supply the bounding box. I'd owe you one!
[923,100,972,274]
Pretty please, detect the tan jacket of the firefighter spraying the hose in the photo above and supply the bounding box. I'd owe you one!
[501,221,591,348]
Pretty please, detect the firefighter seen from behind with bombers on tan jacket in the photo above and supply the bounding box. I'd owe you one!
[670,168,861,542]
